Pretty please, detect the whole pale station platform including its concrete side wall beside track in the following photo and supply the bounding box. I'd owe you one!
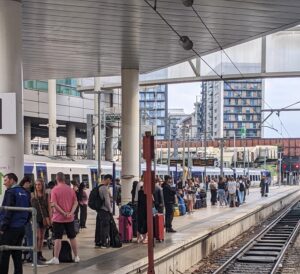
[24,186,300,274]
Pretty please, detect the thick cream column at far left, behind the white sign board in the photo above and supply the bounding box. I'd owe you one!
[0,0,24,182]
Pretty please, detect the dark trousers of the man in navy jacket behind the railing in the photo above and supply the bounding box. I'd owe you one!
[0,227,25,274]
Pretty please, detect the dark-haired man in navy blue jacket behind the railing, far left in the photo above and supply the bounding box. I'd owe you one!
[0,173,30,274]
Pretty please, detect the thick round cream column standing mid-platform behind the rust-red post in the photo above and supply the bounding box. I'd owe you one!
[121,69,139,204]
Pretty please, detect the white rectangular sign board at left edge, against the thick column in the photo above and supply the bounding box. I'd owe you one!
[0,93,17,134]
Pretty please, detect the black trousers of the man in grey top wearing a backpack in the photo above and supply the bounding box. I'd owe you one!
[95,209,111,246]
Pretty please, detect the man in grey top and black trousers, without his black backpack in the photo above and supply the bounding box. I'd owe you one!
[94,174,112,248]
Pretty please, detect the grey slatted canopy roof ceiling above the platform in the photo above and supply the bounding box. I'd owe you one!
[23,0,300,80]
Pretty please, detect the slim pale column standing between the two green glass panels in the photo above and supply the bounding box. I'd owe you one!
[48,79,57,156]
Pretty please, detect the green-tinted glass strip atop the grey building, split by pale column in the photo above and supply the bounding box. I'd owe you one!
[24,79,80,96]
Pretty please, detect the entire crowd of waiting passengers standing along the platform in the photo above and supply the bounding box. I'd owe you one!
[0,172,269,274]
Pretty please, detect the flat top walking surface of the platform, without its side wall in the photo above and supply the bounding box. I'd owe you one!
[18,186,300,274]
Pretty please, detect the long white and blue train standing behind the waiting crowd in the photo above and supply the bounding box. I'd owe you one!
[19,155,271,188]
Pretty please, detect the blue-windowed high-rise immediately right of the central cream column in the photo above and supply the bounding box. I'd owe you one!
[140,85,168,139]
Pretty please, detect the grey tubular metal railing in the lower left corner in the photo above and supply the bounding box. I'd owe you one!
[0,206,37,274]
